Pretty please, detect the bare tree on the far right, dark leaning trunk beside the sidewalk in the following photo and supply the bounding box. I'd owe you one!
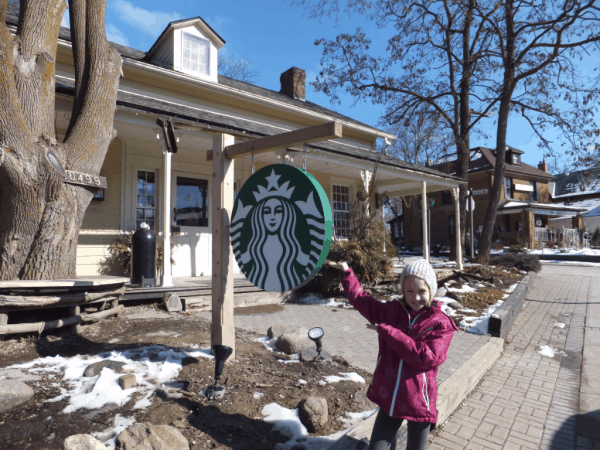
[476,0,600,263]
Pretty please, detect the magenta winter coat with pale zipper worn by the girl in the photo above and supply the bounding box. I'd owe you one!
[342,269,458,423]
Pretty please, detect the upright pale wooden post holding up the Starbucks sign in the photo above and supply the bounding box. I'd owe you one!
[211,134,235,361]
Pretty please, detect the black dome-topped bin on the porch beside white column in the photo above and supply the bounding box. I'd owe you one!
[131,223,156,287]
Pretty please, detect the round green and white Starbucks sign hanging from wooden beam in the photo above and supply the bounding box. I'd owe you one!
[231,164,333,292]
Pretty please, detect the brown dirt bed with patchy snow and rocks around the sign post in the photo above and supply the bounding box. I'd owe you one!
[0,306,373,450]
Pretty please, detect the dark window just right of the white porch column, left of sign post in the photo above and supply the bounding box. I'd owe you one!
[175,177,208,227]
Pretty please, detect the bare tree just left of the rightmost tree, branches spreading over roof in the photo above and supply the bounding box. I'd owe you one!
[296,0,499,258]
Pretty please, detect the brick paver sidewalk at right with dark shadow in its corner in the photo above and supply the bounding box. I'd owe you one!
[428,270,600,450]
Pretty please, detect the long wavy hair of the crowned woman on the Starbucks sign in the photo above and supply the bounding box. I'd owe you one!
[248,197,301,291]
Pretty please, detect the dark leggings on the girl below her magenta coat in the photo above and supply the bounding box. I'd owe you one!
[367,409,431,450]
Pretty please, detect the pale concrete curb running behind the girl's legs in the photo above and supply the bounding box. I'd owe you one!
[327,338,504,450]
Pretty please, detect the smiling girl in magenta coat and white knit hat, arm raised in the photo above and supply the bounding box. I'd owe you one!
[331,259,458,450]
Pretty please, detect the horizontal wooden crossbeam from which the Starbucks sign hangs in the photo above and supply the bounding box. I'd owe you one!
[206,122,342,161]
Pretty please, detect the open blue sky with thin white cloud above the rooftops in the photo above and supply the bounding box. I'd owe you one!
[63,0,600,170]
